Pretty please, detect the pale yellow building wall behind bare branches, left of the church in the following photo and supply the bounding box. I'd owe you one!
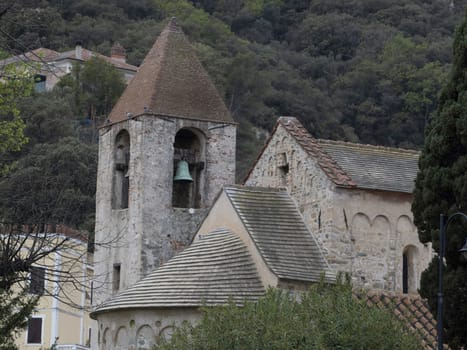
[16,235,94,350]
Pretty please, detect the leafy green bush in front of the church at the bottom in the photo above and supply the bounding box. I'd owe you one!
[157,283,421,350]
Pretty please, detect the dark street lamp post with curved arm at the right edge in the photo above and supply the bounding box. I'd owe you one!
[437,212,467,350]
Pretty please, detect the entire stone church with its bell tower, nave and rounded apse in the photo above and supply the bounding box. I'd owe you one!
[91,19,433,350]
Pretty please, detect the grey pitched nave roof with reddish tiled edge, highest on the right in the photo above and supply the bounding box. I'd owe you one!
[278,117,419,193]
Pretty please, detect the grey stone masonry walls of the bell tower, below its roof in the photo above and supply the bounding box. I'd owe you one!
[95,115,236,302]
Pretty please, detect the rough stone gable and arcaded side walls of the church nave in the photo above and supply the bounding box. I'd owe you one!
[246,126,432,292]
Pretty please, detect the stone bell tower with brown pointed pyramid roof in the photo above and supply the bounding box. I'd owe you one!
[94,20,236,303]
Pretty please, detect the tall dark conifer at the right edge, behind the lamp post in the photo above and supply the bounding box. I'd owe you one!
[412,8,467,348]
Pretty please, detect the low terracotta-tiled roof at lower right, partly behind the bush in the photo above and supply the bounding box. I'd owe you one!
[366,291,437,349]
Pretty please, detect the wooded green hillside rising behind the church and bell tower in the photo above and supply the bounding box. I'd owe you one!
[0,0,467,178]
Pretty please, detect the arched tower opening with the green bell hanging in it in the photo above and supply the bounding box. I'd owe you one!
[172,129,205,208]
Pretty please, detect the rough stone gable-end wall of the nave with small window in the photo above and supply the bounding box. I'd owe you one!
[246,126,342,270]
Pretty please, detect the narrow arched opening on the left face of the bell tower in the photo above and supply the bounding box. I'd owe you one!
[112,130,130,209]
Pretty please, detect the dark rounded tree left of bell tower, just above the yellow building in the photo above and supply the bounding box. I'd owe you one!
[0,137,97,228]
